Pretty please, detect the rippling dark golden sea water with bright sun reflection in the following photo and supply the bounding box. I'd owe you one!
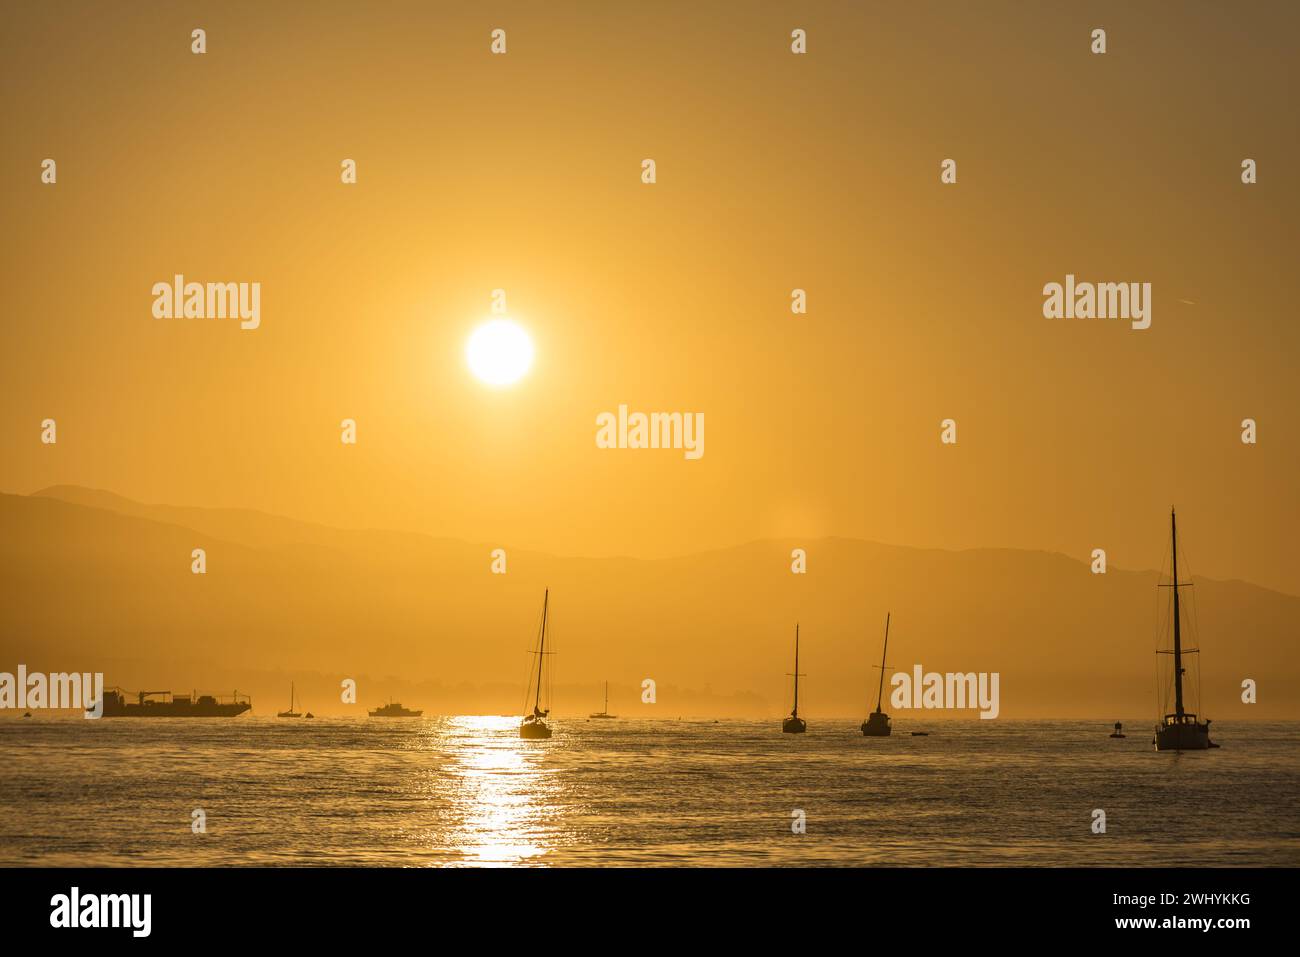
[0,715,1300,867]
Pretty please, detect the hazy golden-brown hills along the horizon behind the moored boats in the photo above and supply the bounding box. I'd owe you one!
[0,488,1300,722]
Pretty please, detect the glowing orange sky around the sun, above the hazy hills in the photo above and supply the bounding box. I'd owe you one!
[0,3,1300,594]
